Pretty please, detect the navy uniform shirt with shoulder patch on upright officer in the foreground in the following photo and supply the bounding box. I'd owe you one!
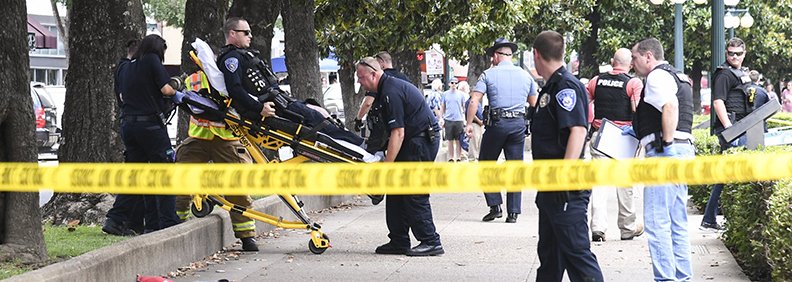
[531,67,588,160]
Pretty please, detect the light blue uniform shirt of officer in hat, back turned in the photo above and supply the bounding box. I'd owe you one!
[473,60,536,113]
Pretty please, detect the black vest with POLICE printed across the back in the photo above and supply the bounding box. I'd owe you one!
[594,73,633,121]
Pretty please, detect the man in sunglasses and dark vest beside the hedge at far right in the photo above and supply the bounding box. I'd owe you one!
[701,37,754,230]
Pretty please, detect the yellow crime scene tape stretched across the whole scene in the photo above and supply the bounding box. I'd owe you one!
[0,153,792,195]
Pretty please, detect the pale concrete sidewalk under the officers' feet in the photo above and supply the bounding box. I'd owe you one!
[174,191,749,281]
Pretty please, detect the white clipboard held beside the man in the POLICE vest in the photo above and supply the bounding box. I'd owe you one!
[592,118,640,159]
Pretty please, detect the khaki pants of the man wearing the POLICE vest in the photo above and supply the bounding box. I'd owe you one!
[586,132,637,237]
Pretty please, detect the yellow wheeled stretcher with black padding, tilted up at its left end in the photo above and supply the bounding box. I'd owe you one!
[182,51,363,254]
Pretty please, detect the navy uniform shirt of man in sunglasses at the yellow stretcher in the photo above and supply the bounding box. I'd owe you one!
[217,45,264,116]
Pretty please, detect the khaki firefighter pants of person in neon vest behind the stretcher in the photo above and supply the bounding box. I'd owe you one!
[176,137,256,238]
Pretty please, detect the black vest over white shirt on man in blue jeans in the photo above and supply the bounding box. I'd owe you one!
[633,64,693,139]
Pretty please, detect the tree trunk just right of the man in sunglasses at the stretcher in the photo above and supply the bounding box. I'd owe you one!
[282,0,324,103]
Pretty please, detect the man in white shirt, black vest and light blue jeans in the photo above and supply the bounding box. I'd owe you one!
[631,38,695,281]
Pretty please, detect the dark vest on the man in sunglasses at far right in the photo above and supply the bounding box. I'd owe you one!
[712,63,752,128]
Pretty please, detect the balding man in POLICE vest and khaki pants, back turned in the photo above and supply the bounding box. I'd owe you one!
[586,48,643,241]
